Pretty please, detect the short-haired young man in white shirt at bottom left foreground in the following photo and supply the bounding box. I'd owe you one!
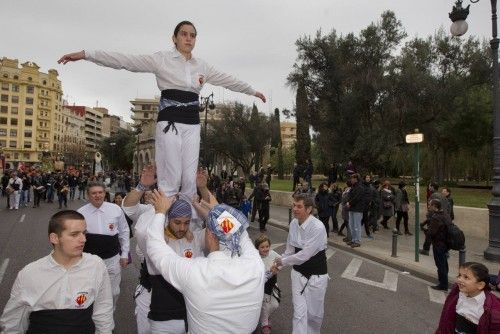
[0,210,114,334]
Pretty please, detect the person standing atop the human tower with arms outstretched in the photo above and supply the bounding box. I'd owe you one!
[58,21,266,211]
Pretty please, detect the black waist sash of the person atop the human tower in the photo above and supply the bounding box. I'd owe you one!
[157,89,200,124]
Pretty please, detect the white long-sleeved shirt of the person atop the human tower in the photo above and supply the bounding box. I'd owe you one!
[85,48,256,95]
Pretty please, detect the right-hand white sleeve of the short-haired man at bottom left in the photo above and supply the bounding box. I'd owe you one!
[92,261,115,334]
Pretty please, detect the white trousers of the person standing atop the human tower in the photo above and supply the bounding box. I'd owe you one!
[155,121,200,200]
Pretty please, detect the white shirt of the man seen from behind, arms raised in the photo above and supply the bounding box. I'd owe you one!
[147,214,264,334]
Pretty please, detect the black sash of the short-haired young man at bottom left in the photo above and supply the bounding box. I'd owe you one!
[26,304,95,334]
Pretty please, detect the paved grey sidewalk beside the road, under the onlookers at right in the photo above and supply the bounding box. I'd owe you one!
[269,205,500,282]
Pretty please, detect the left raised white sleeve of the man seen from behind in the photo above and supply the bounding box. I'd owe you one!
[147,213,194,292]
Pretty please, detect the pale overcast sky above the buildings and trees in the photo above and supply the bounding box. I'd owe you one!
[0,0,491,120]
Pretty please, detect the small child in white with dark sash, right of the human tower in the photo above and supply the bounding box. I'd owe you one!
[255,234,281,334]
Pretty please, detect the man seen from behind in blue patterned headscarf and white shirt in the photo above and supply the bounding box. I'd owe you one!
[147,190,265,334]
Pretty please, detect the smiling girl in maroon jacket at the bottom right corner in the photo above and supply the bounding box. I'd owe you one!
[436,262,500,334]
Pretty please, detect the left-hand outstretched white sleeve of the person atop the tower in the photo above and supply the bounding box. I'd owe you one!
[85,50,160,73]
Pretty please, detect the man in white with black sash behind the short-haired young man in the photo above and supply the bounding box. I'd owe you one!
[78,182,130,307]
